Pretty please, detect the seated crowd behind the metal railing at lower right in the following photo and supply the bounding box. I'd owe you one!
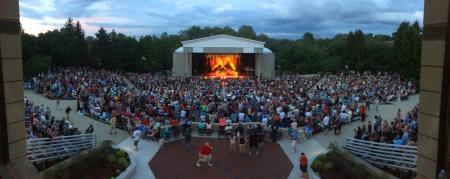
[354,105,419,146]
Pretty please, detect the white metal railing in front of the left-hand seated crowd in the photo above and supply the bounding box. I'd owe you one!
[26,133,96,162]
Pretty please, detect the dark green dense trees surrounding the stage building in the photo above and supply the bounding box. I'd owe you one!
[22,18,422,80]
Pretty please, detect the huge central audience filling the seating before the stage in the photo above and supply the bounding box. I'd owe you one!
[28,68,415,140]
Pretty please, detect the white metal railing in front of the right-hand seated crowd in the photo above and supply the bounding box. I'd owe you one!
[344,138,417,171]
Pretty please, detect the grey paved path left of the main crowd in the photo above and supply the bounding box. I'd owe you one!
[24,90,128,144]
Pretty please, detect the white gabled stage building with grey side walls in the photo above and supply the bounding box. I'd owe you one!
[172,35,275,78]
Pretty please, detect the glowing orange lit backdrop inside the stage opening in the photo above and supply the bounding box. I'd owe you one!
[207,54,240,78]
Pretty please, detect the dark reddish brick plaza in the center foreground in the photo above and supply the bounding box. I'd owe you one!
[149,137,293,179]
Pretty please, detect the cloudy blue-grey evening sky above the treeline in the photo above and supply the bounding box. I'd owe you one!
[19,0,424,39]
